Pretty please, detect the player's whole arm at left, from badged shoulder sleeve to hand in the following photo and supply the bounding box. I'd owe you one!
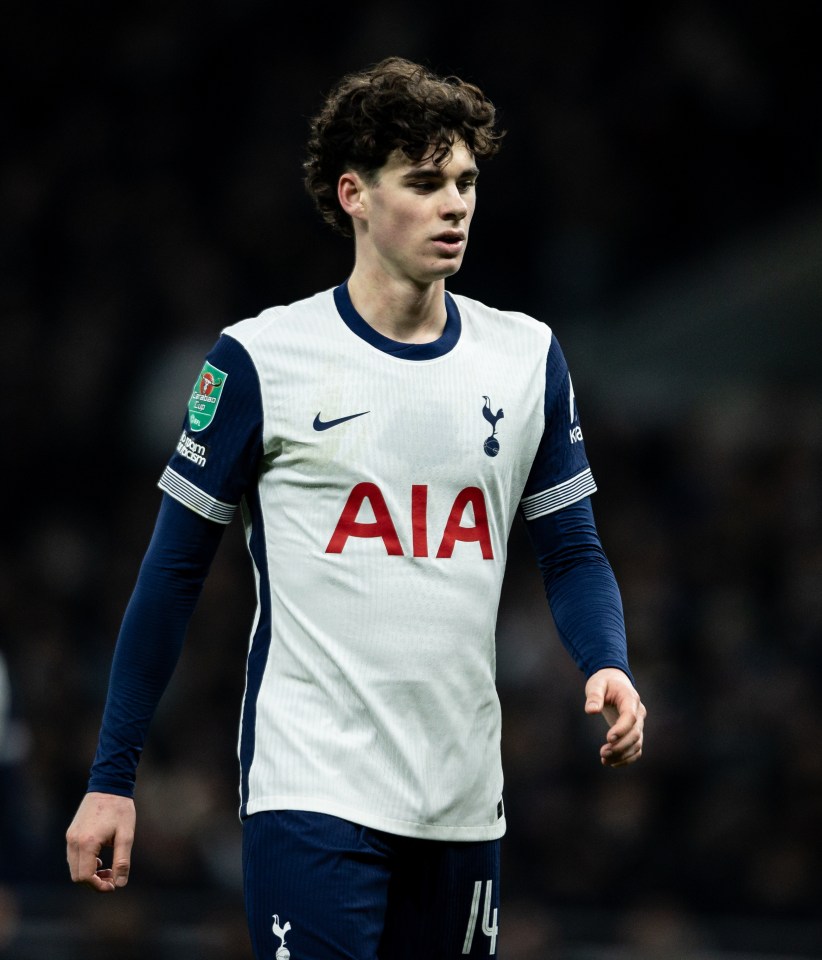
[66,335,262,892]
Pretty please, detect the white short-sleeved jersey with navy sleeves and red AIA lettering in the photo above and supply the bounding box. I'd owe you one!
[160,285,595,840]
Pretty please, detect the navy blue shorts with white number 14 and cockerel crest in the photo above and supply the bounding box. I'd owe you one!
[243,810,500,960]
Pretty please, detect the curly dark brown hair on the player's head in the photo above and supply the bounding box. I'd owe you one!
[303,57,504,237]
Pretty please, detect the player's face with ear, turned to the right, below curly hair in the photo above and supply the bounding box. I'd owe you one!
[354,141,478,285]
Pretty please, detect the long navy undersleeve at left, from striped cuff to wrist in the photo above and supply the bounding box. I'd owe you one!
[88,494,225,797]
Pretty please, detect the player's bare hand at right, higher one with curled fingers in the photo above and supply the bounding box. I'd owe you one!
[585,667,647,767]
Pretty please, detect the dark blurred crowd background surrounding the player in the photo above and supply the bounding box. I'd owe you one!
[0,0,822,960]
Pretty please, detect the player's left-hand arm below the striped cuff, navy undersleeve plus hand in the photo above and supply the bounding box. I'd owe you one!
[66,495,224,893]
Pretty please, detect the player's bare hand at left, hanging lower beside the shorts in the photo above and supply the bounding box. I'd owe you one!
[66,793,137,893]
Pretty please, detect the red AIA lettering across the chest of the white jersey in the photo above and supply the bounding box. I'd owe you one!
[325,483,494,560]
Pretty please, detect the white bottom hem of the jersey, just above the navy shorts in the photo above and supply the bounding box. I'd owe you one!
[240,797,506,841]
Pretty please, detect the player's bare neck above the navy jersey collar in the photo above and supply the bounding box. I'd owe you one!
[348,267,446,343]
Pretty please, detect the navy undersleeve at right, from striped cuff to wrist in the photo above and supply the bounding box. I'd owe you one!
[525,497,634,683]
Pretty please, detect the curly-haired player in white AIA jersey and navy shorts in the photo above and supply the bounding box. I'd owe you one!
[67,58,645,960]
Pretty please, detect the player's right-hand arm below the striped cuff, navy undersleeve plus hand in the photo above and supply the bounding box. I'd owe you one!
[526,497,646,767]
